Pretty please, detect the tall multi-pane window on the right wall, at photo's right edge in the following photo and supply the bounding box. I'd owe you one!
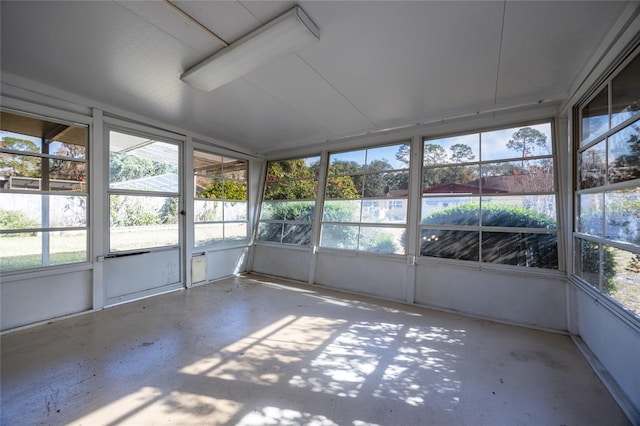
[574,50,640,316]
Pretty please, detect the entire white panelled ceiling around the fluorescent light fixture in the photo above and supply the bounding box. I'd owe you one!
[0,0,628,153]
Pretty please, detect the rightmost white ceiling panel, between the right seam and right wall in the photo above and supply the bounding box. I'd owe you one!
[498,1,626,104]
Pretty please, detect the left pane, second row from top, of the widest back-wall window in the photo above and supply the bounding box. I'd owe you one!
[422,165,480,194]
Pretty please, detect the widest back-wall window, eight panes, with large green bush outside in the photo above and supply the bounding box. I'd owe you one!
[420,123,558,269]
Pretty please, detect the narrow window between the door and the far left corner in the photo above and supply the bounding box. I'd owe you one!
[193,151,248,247]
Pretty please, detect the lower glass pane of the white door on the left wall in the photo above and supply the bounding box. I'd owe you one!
[109,195,178,251]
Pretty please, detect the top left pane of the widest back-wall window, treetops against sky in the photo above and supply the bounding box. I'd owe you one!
[423,133,480,166]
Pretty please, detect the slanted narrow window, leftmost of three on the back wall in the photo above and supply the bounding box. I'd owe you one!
[258,157,320,246]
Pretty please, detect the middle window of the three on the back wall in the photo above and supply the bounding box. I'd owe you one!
[320,143,411,254]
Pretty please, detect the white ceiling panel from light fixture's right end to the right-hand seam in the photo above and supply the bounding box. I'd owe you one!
[300,2,502,124]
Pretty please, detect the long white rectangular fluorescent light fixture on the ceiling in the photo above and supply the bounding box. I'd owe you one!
[180,6,320,92]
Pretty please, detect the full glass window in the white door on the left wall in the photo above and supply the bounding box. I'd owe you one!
[108,130,180,252]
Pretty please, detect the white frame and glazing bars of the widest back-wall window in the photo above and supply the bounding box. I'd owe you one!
[416,118,565,274]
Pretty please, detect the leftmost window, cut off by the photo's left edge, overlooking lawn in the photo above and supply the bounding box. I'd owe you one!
[0,111,88,272]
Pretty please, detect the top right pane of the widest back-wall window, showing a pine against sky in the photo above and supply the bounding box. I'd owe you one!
[480,123,553,161]
